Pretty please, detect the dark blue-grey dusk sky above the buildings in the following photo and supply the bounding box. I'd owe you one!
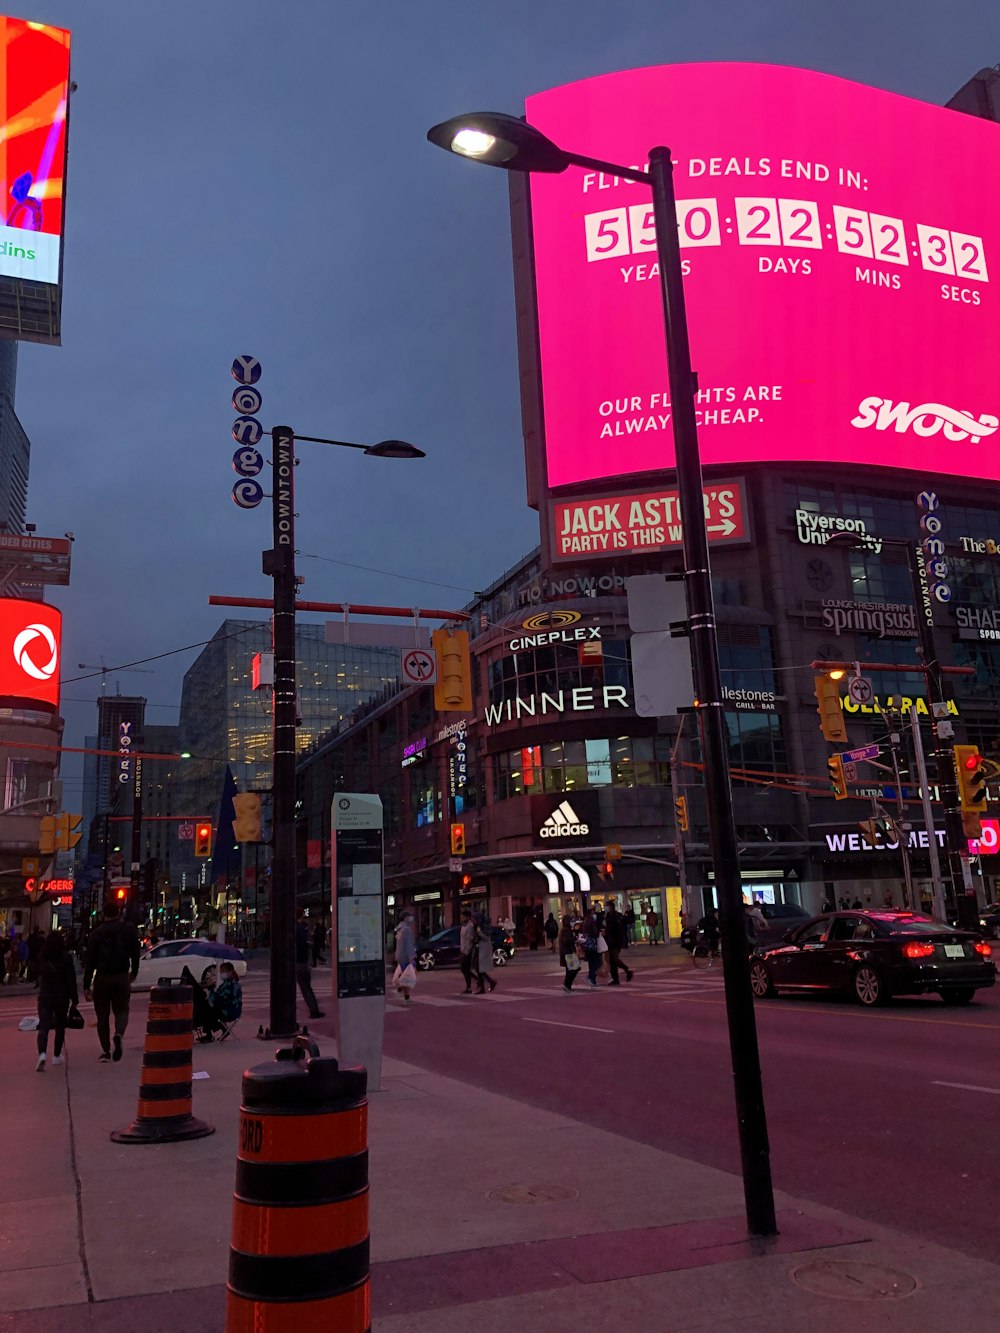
[12,0,1000,809]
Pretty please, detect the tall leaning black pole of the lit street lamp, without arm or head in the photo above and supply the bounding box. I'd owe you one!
[649,140,777,1236]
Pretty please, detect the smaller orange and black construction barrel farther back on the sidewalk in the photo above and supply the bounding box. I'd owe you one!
[111,986,215,1144]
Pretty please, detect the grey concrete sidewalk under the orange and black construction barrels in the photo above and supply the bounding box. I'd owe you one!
[0,991,1000,1333]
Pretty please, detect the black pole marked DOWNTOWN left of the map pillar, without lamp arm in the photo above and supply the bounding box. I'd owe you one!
[263,425,299,1037]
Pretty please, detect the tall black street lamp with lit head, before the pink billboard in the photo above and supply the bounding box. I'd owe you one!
[427,112,777,1236]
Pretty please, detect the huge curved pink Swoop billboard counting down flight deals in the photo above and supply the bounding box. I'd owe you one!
[527,64,1000,488]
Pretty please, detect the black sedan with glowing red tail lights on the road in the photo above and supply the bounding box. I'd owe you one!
[751,912,996,1008]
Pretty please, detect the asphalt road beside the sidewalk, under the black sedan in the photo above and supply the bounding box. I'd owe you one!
[378,946,1000,1261]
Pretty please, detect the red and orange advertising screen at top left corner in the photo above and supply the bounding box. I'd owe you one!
[0,16,69,341]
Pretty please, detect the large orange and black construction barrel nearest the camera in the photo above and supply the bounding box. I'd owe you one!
[225,1038,372,1333]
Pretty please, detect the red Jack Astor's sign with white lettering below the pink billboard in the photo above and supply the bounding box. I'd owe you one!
[549,479,749,561]
